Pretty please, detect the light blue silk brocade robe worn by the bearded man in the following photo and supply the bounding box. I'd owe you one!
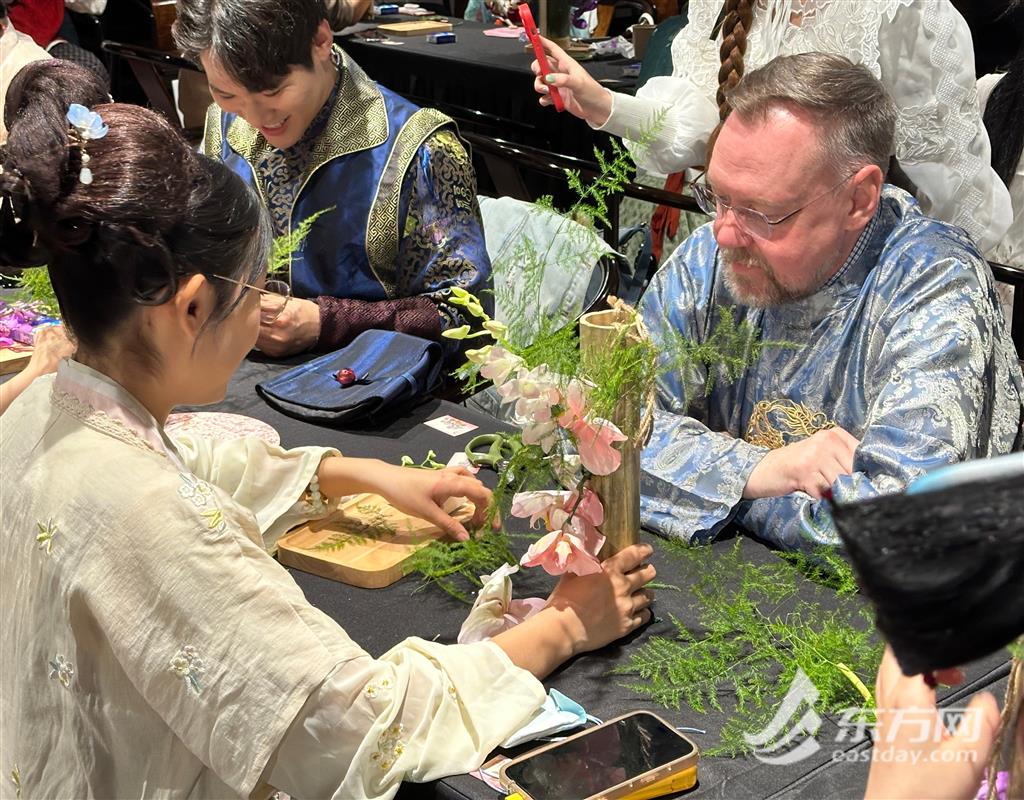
[641,185,1024,549]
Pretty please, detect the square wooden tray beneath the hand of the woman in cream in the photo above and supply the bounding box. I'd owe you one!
[278,495,473,589]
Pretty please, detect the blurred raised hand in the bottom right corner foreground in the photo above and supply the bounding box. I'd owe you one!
[864,646,999,800]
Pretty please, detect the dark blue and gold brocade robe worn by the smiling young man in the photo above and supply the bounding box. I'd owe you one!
[203,48,493,350]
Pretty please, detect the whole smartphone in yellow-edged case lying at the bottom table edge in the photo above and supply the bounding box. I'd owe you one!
[501,711,698,800]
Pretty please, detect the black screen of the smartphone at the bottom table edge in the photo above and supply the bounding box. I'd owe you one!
[505,713,693,800]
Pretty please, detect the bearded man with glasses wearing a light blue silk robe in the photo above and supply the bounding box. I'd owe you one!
[641,53,1024,549]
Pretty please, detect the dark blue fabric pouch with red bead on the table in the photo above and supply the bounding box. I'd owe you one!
[256,330,443,425]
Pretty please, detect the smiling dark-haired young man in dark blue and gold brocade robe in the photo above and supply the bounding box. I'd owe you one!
[174,0,490,355]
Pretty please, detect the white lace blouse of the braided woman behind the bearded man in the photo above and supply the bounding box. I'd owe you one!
[601,0,1012,251]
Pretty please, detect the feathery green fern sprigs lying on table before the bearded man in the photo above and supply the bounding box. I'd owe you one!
[614,540,883,755]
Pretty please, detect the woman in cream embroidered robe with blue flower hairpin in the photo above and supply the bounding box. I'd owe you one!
[0,59,654,800]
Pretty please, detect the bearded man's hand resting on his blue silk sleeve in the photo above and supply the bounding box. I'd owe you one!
[743,427,860,500]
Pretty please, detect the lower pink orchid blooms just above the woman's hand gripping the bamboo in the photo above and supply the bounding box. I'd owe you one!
[512,489,604,575]
